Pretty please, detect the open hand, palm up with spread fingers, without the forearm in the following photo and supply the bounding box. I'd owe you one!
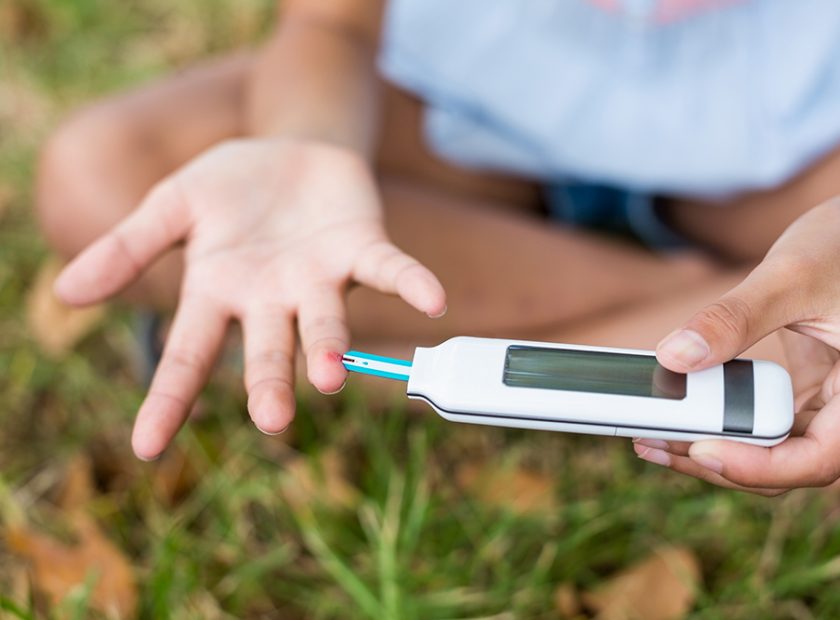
[56,139,445,459]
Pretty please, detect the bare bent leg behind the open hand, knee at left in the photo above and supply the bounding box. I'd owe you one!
[38,56,709,339]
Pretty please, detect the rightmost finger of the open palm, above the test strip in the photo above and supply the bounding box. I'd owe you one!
[353,241,446,318]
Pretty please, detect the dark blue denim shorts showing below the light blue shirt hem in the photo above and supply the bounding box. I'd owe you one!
[544,182,691,251]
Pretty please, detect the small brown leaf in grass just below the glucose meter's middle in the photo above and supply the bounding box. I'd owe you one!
[456,463,557,515]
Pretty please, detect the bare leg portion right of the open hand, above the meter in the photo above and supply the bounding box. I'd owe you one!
[350,178,717,344]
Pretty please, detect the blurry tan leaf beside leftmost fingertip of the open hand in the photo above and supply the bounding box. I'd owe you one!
[26,259,105,358]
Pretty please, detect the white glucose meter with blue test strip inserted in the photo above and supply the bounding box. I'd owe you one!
[343,336,793,446]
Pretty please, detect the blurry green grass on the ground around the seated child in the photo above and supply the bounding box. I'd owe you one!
[0,0,840,619]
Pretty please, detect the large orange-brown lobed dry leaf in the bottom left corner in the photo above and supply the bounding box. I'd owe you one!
[6,457,137,618]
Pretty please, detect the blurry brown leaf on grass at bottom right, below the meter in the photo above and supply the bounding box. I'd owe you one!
[582,547,700,620]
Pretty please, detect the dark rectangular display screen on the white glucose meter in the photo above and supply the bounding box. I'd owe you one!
[503,345,686,400]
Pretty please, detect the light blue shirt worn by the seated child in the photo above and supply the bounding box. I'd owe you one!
[380,0,840,196]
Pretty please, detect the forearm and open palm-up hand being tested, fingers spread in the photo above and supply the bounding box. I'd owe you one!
[51,0,445,459]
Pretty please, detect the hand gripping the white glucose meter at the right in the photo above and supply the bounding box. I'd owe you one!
[636,200,840,495]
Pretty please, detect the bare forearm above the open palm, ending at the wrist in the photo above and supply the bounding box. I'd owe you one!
[248,0,385,157]
